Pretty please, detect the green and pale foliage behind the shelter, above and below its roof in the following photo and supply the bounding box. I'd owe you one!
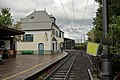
[0,8,22,42]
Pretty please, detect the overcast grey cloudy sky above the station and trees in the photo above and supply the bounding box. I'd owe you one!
[0,0,98,41]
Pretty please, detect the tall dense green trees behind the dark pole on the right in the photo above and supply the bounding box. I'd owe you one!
[93,0,120,53]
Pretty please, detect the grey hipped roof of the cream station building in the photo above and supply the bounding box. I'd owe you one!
[21,10,64,33]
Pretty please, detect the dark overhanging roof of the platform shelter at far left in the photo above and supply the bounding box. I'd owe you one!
[0,26,25,36]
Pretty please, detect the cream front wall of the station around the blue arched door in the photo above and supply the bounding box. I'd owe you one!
[17,31,51,54]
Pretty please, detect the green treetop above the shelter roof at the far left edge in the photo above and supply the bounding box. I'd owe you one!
[0,8,12,27]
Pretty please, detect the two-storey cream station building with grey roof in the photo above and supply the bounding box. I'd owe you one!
[17,10,64,54]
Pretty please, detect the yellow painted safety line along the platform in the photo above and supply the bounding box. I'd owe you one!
[2,56,64,80]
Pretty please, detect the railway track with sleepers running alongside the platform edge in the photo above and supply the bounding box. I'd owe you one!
[44,54,76,80]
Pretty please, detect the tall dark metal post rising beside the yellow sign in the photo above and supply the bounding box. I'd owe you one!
[102,0,112,80]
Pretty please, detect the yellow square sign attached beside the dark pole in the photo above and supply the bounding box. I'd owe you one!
[87,42,100,56]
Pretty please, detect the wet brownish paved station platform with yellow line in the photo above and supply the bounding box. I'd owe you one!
[0,53,67,80]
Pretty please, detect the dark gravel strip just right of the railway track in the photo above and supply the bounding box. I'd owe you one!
[73,52,91,80]
